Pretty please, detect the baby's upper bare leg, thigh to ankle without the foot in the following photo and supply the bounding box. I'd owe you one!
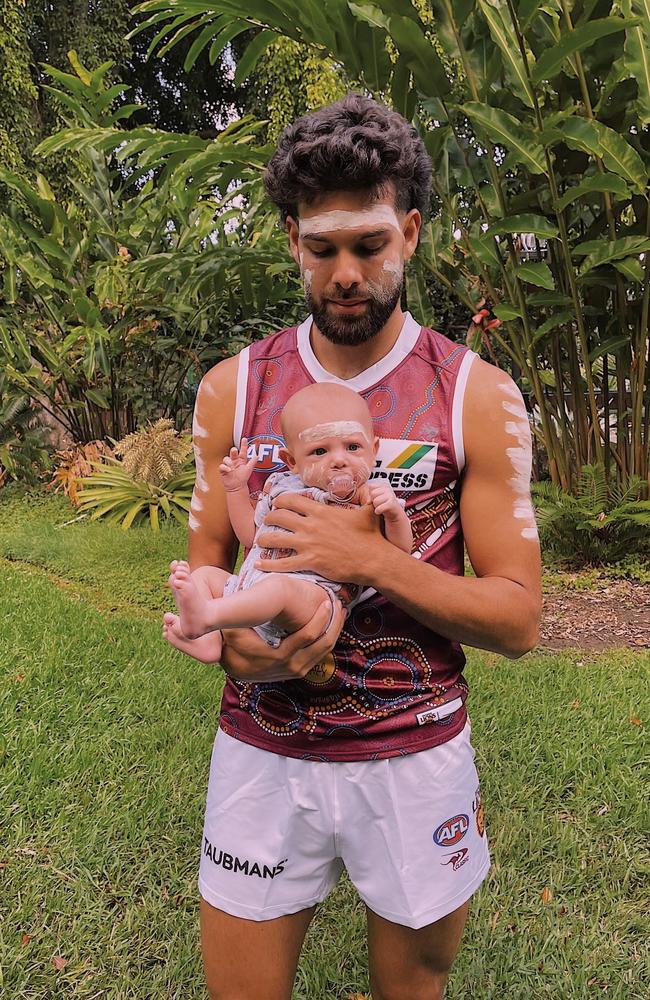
[197,573,326,632]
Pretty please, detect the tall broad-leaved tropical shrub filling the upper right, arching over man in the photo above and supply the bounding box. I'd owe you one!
[136,0,650,490]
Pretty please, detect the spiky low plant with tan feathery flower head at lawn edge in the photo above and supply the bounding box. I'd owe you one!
[79,420,195,531]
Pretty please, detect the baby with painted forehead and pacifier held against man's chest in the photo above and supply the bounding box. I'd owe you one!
[163,383,412,663]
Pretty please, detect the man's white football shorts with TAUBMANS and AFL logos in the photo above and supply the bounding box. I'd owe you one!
[199,723,490,928]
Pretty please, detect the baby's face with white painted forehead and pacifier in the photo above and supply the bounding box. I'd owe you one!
[290,420,377,499]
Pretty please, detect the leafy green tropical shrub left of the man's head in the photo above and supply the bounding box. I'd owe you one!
[0,53,301,442]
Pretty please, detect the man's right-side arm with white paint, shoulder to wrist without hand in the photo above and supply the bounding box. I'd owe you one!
[362,361,541,659]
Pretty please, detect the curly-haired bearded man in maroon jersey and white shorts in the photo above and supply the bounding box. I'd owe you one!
[180,95,541,1000]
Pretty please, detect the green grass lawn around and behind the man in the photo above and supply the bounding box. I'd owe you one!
[0,493,650,1000]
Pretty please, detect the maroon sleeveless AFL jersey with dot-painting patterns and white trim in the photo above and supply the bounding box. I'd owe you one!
[220,313,476,761]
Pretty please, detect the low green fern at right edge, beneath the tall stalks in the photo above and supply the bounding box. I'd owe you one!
[532,463,650,566]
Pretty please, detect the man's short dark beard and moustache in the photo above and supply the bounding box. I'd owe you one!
[305,271,404,347]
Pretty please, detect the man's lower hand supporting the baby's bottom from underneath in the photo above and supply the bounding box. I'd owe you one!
[221,598,345,684]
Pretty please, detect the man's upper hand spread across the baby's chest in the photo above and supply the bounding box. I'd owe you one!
[256,493,392,586]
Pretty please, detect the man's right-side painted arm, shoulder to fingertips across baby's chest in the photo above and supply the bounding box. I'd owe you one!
[260,360,541,659]
